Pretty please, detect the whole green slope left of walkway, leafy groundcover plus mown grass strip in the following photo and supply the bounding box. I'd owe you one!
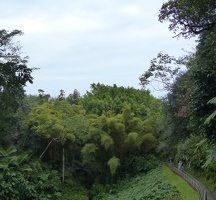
[93,166,199,200]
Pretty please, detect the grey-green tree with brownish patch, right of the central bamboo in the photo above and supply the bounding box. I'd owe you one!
[157,70,195,156]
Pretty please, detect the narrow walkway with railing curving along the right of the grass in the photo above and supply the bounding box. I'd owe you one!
[165,162,214,200]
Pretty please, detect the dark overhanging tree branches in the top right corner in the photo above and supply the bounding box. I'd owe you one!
[159,0,216,38]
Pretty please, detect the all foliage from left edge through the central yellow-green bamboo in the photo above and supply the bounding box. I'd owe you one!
[0,30,162,199]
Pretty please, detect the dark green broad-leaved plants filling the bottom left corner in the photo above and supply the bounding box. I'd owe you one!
[0,146,61,200]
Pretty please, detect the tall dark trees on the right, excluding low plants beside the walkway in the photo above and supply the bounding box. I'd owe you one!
[140,0,216,158]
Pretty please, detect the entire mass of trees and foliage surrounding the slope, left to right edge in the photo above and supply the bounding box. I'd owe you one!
[0,0,216,199]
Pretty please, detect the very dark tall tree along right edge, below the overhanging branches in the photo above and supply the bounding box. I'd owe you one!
[192,28,216,139]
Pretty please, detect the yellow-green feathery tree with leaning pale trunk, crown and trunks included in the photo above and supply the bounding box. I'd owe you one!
[23,100,88,182]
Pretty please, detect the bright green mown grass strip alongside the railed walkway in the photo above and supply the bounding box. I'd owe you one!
[162,165,200,200]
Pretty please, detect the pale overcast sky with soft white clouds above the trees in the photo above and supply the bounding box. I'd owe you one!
[0,0,195,97]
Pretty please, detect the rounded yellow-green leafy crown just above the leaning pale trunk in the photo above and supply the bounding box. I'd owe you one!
[24,100,84,157]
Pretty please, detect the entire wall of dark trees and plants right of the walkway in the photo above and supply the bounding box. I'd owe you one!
[140,0,216,194]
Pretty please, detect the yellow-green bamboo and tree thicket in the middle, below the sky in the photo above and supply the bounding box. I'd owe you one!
[19,86,162,196]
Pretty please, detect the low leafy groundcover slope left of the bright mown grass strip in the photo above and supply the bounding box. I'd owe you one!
[93,167,182,200]
